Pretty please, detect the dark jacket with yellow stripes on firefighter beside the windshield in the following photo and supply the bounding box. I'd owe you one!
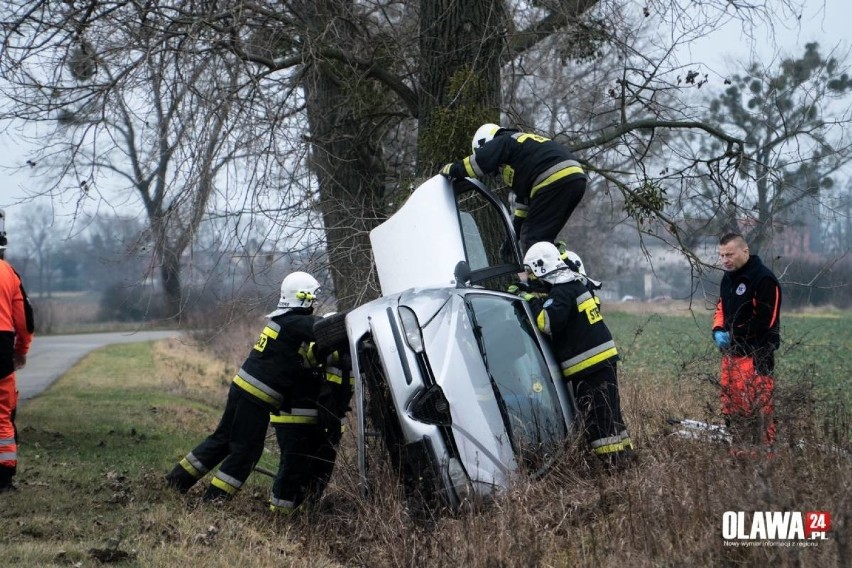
[531,280,618,379]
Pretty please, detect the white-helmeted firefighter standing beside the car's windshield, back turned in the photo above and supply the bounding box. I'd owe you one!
[524,242,633,468]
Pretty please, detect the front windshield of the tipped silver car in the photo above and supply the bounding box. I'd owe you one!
[466,294,566,471]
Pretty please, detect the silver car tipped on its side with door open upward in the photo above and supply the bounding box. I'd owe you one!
[322,176,574,508]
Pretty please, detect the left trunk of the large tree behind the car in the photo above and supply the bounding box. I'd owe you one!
[302,0,384,310]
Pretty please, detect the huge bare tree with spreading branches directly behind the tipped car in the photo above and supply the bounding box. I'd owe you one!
[0,0,828,308]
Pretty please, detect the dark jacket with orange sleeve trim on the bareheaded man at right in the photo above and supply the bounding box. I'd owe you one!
[713,255,781,357]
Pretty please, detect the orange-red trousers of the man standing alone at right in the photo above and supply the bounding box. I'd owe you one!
[721,355,775,444]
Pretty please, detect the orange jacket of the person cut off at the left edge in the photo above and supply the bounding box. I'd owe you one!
[0,260,35,379]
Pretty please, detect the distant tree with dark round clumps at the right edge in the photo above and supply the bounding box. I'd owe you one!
[696,43,852,255]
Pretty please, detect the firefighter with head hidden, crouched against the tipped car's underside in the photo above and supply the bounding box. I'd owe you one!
[269,350,355,515]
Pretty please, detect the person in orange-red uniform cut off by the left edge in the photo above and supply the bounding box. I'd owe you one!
[0,210,35,493]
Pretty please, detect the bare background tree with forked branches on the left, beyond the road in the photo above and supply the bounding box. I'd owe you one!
[4,3,296,316]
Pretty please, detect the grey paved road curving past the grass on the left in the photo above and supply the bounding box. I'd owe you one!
[17,331,180,402]
